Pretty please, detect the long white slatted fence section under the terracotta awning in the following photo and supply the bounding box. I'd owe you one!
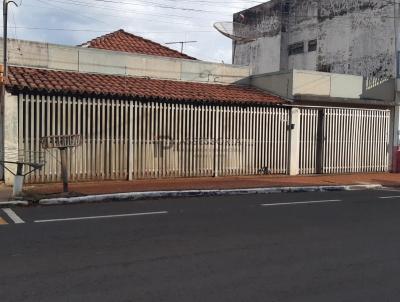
[18,94,290,183]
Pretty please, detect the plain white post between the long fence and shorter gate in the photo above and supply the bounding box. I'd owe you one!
[289,108,300,175]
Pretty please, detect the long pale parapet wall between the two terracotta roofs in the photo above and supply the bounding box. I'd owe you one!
[0,39,250,83]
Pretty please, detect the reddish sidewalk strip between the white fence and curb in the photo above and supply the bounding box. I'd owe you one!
[24,173,400,198]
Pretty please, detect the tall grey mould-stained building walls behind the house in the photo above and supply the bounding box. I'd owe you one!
[234,0,396,79]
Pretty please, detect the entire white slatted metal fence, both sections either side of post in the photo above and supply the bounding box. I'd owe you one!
[18,94,390,183]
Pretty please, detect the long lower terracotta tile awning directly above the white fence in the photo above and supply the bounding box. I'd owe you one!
[6,66,286,104]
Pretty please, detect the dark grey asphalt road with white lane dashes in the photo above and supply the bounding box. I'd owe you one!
[0,190,400,302]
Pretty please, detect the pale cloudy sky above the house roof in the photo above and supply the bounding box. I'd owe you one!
[3,0,265,63]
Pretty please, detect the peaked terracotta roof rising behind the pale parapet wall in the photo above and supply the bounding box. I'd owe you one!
[79,29,196,60]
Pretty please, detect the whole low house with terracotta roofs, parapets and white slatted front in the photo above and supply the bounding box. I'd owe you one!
[1,30,390,188]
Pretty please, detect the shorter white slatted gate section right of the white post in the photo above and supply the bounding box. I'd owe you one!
[300,108,390,174]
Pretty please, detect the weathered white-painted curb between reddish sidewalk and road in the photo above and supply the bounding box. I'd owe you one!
[35,184,382,206]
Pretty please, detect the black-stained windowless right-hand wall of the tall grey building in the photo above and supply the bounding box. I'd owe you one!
[318,0,396,78]
